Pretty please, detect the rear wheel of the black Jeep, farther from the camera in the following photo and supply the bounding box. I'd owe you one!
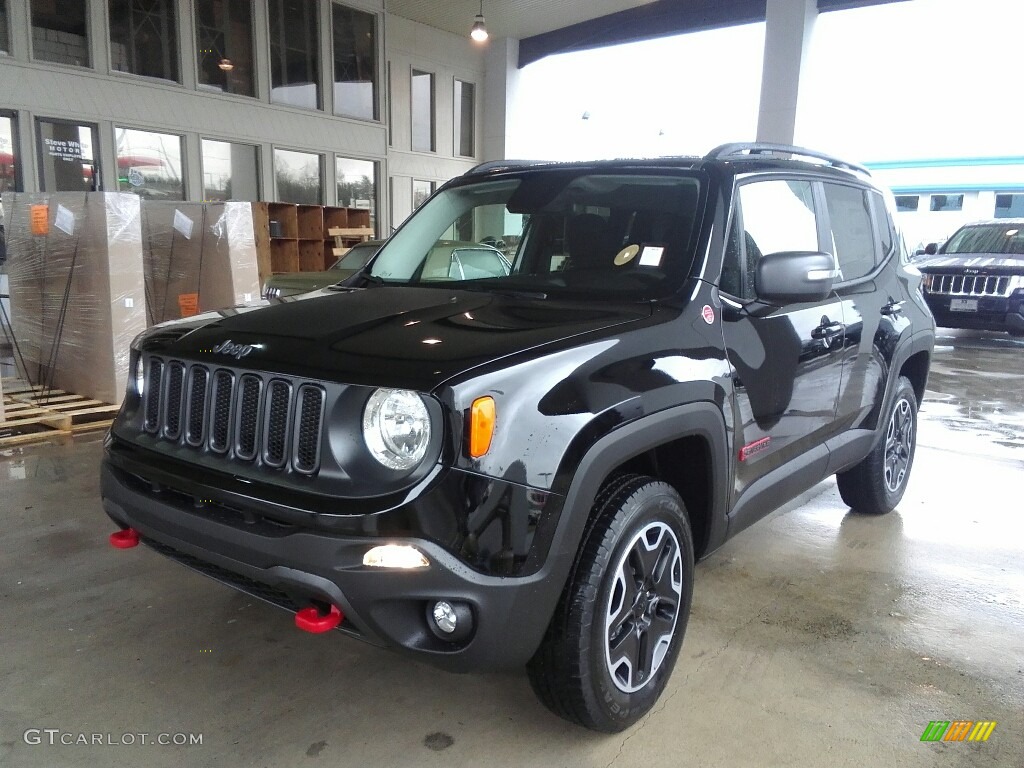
[836,376,918,515]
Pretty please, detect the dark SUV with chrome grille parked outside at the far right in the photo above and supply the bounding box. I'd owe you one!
[919,219,1024,336]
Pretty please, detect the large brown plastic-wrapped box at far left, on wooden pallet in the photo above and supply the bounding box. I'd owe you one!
[3,193,145,402]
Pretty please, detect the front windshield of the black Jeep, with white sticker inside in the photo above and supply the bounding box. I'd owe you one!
[371,170,700,298]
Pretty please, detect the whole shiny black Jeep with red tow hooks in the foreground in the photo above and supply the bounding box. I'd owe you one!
[101,144,934,731]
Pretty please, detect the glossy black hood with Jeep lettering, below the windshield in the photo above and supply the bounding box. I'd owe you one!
[143,287,651,391]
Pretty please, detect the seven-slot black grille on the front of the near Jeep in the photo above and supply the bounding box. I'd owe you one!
[143,357,325,474]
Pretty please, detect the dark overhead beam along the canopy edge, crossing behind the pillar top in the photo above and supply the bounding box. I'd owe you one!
[519,0,906,69]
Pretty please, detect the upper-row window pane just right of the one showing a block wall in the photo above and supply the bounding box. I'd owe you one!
[110,0,178,82]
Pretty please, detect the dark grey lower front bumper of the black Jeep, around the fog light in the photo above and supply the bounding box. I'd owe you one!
[100,456,567,672]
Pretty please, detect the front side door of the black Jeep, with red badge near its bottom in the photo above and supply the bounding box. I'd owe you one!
[720,177,844,507]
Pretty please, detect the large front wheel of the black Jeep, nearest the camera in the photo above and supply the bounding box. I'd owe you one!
[527,475,693,733]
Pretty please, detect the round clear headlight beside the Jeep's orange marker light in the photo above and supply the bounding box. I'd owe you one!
[362,389,430,470]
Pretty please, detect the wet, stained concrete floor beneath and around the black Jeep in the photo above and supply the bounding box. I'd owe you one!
[0,332,1024,768]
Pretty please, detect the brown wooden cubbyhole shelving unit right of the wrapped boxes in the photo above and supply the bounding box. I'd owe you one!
[253,203,374,282]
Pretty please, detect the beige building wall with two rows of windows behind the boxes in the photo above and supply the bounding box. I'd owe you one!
[0,0,484,236]
